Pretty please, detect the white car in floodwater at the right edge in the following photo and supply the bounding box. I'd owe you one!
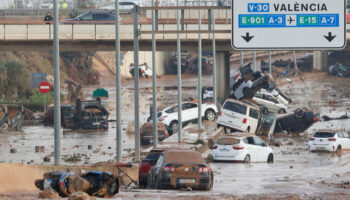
[308,130,350,152]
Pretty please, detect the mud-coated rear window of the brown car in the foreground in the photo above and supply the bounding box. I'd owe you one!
[164,151,205,164]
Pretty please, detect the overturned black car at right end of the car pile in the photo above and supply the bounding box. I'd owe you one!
[274,109,319,133]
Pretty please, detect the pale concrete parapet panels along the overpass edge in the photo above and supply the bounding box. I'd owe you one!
[0,24,231,40]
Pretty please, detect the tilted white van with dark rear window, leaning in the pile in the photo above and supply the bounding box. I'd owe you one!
[217,99,262,133]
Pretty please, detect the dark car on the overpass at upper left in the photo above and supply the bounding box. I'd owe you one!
[63,11,115,24]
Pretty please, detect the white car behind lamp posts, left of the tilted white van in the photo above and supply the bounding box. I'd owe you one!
[154,102,218,133]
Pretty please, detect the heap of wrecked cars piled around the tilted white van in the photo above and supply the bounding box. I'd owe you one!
[217,63,318,136]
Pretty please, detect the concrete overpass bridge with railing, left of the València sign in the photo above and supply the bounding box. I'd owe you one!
[0,6,350,51]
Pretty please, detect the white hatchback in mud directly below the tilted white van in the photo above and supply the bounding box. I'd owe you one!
[212,132,274,163]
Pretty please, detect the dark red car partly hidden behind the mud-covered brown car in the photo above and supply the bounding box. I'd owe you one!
[139,149,165,188]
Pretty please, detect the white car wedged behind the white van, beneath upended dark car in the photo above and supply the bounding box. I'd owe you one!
[253,92,287,113]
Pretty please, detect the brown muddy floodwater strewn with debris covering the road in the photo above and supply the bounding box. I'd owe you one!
[0,73,350,199]
